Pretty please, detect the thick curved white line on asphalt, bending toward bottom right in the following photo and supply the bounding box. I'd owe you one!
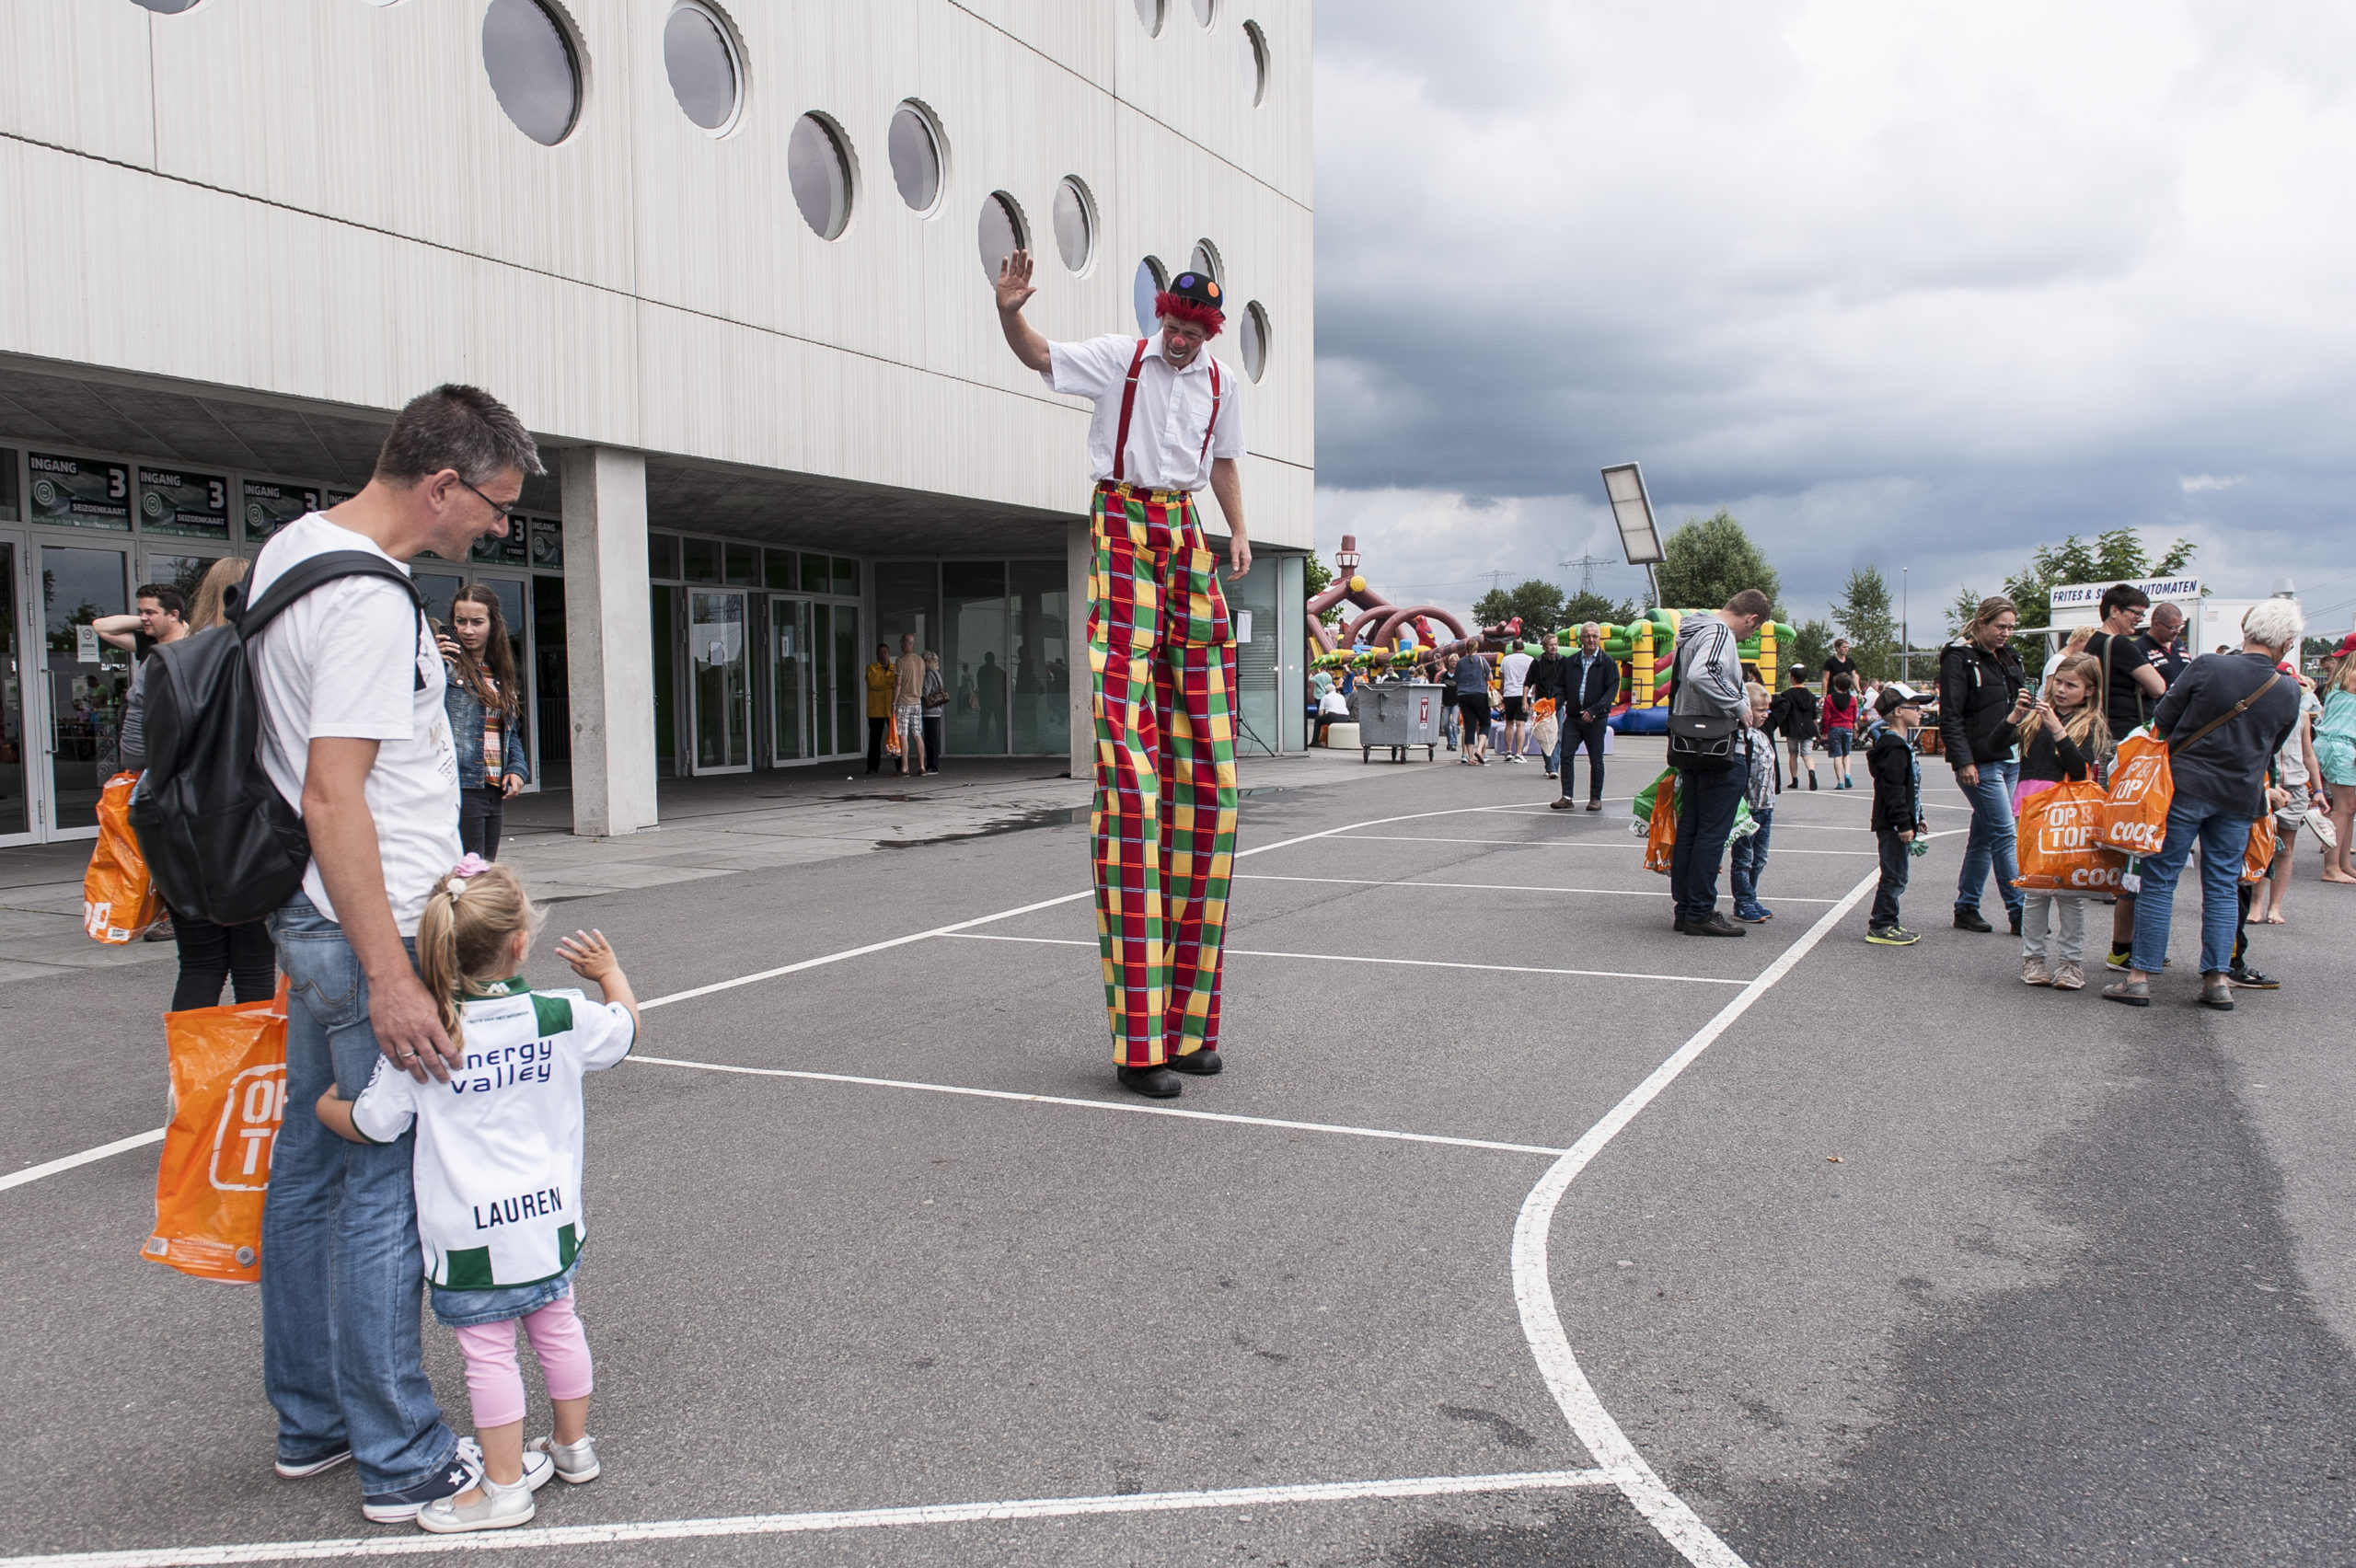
[1513,871,1880,1568]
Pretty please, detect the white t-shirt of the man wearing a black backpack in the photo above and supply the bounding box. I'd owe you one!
[248,511,462,937]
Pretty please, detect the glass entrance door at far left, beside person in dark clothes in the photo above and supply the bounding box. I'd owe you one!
[38,544,132,838]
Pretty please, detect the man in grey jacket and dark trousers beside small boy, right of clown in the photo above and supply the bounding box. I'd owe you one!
[1668,589,1774,937]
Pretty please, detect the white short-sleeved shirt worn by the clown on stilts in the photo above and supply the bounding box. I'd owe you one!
[1042,332,1244,490]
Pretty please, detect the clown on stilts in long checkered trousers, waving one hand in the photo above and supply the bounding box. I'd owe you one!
[997,252,1251,1100]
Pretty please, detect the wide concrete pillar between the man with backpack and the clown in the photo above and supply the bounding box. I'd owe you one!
[563,447,655,838]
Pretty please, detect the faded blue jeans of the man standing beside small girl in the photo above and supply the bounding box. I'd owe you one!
[261,893,457,1493]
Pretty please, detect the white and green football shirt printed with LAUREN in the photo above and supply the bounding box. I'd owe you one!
[351,984,636,1290]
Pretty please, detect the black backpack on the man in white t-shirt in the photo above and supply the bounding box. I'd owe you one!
[130,551,424,926]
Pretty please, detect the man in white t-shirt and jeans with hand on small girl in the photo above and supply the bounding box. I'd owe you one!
[245,386,544,1523]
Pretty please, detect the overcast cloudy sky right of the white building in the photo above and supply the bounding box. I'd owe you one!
[1317,0,2356,636]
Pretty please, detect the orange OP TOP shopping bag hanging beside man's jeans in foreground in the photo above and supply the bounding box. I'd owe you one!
[139,979,291,1286]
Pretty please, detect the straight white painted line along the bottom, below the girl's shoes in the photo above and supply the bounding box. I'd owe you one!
[0,1470,1611,1568]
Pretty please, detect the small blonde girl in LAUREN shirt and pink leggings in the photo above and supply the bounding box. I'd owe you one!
[318,855,639,1535]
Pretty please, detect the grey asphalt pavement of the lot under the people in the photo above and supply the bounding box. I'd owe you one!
[0,742,2356,1568]
